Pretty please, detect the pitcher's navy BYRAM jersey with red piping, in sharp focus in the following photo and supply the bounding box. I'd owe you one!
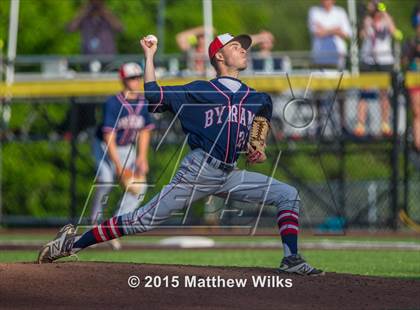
[144,77,272,163]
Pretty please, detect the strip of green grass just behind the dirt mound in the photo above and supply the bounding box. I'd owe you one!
[0,250,420,280]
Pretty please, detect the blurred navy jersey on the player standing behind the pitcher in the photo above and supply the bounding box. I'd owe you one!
[97,93,154,145]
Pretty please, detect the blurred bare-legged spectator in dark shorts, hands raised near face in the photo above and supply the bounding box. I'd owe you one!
[354,0,397,136]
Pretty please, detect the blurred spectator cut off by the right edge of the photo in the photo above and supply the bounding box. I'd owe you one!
[402,7,420,152]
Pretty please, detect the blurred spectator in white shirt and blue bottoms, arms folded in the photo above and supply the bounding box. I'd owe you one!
[308,0,352,70]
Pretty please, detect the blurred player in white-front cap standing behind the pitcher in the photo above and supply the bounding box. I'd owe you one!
[91,63,154,250]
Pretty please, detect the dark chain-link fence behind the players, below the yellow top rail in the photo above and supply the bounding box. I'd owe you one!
[1,75,420,232]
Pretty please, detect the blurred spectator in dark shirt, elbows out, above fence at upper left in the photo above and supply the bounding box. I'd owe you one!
[67,0,123,71]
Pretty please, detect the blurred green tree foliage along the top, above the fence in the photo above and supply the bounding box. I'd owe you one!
[0,0,417,54]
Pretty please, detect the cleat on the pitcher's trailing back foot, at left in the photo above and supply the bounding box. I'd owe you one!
[38,224,76,264]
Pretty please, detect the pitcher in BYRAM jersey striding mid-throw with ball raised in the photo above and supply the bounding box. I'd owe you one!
[38,34,322,275]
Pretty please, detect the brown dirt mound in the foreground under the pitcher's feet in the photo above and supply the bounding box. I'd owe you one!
[0,262,420,309]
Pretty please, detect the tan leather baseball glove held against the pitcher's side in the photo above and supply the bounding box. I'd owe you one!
[246,116,270,164]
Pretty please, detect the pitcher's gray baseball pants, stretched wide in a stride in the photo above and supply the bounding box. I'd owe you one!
[122,149,300,234]
